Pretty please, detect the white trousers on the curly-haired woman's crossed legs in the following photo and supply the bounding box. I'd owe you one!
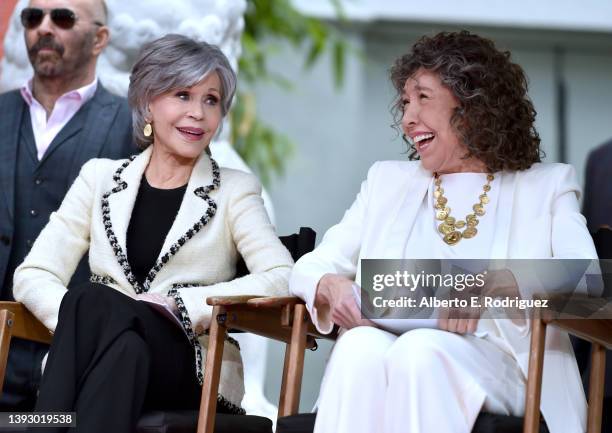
[314,327,525,433]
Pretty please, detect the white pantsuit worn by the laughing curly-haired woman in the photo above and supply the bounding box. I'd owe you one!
[290,162,597,433]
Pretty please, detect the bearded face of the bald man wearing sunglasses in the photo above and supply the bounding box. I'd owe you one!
[25,0,107,79]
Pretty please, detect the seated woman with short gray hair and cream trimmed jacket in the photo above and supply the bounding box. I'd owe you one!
[14,35,293,433]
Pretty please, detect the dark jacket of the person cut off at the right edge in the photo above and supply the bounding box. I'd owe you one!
[582,140,612,232]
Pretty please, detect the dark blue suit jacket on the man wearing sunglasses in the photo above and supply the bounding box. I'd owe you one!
[0,83,137,293]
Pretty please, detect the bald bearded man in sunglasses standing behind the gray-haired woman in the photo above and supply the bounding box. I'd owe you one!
[0,0,136,410]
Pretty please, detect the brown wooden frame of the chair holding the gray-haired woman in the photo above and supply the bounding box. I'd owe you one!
[0,296,323,433]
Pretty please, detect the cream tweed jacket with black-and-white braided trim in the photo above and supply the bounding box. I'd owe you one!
[13,148,293,412]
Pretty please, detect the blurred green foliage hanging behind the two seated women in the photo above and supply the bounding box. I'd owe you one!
[231,0,347,185]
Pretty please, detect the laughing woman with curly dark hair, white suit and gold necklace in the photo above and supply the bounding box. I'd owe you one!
[290,32,597,433]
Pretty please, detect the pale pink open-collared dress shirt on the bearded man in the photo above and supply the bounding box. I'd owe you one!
[21,78,98,161]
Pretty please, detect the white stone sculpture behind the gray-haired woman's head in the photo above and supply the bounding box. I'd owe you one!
[0,0,277,421]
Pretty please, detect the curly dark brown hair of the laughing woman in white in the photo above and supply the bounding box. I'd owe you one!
[390,31,543,172]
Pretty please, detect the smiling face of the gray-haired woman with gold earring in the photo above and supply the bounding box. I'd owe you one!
[146,72,223,162]
